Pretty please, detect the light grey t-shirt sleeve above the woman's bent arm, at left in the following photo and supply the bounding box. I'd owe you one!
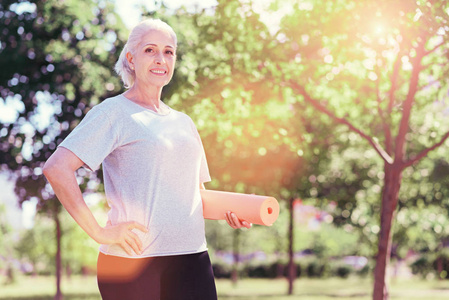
[58,106,118,171]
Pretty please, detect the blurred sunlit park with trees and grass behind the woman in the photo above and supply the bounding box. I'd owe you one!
[0,0,449,300]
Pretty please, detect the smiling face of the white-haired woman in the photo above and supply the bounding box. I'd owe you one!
[127,30,176,87]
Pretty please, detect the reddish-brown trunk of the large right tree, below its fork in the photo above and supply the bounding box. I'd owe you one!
[373,164,402,300]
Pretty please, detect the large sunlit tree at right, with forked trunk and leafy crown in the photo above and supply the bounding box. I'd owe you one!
[272,0,449,299]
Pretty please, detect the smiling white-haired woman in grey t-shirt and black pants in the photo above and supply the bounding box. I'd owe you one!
[44,20,251,300]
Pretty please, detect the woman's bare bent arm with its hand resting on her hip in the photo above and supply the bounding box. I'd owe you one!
[43,147,147,255]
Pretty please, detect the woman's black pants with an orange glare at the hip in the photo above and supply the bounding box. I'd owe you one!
[97,251,217,300]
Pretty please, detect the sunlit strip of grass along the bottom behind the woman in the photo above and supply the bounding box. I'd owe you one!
[0,276,449,300]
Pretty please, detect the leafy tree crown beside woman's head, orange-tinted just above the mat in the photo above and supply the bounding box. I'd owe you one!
[145,1,310,195]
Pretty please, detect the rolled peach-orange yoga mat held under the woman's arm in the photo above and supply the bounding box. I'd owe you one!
[200,189,279,226]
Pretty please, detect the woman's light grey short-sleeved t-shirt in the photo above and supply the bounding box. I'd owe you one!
[59,95,210,257]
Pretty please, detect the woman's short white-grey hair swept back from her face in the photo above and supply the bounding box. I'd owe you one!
[114,19,178,88]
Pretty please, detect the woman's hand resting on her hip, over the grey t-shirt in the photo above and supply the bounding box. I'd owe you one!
[97,221,148,255]
